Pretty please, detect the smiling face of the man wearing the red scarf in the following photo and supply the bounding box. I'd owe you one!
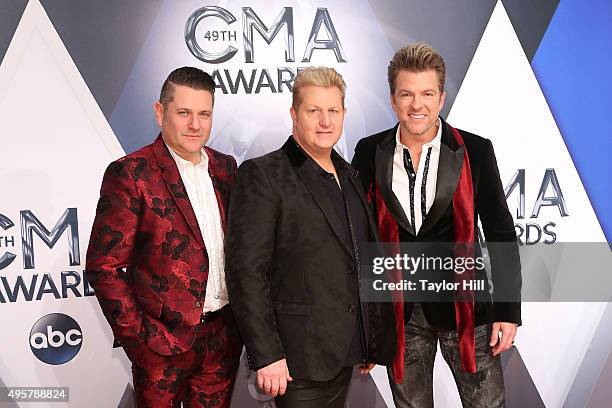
[391,70,446,140]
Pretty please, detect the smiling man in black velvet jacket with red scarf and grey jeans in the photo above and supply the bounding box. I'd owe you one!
[353,43,521,408]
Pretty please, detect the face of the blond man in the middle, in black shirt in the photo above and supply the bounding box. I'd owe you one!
[290,86,345,156]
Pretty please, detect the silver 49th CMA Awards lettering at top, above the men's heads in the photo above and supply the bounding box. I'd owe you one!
[185,6,347,94]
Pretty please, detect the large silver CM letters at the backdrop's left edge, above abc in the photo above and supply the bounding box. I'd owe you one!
[0,208,81,270]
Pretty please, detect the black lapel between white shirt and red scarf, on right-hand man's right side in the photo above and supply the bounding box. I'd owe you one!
[419,119,465,234]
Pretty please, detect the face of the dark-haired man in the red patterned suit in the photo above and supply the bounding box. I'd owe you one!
[155,85,213,163]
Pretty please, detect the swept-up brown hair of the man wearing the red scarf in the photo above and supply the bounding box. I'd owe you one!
[387,43,446,94]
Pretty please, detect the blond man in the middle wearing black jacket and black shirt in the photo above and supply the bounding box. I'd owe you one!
[226,68,395,408]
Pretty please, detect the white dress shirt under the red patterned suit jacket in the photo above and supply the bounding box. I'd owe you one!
[166,145,229,313]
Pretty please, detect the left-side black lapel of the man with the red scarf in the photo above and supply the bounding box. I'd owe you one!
[374,124,414,235]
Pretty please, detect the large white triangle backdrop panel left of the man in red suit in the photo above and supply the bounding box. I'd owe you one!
[0,0,130,406]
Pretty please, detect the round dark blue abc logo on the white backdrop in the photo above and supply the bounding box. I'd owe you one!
[30,313,83,365]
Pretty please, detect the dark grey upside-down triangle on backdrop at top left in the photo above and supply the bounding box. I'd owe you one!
[40,0,161,119]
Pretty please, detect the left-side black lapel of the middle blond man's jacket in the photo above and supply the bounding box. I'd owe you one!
[282,136,354,257]
